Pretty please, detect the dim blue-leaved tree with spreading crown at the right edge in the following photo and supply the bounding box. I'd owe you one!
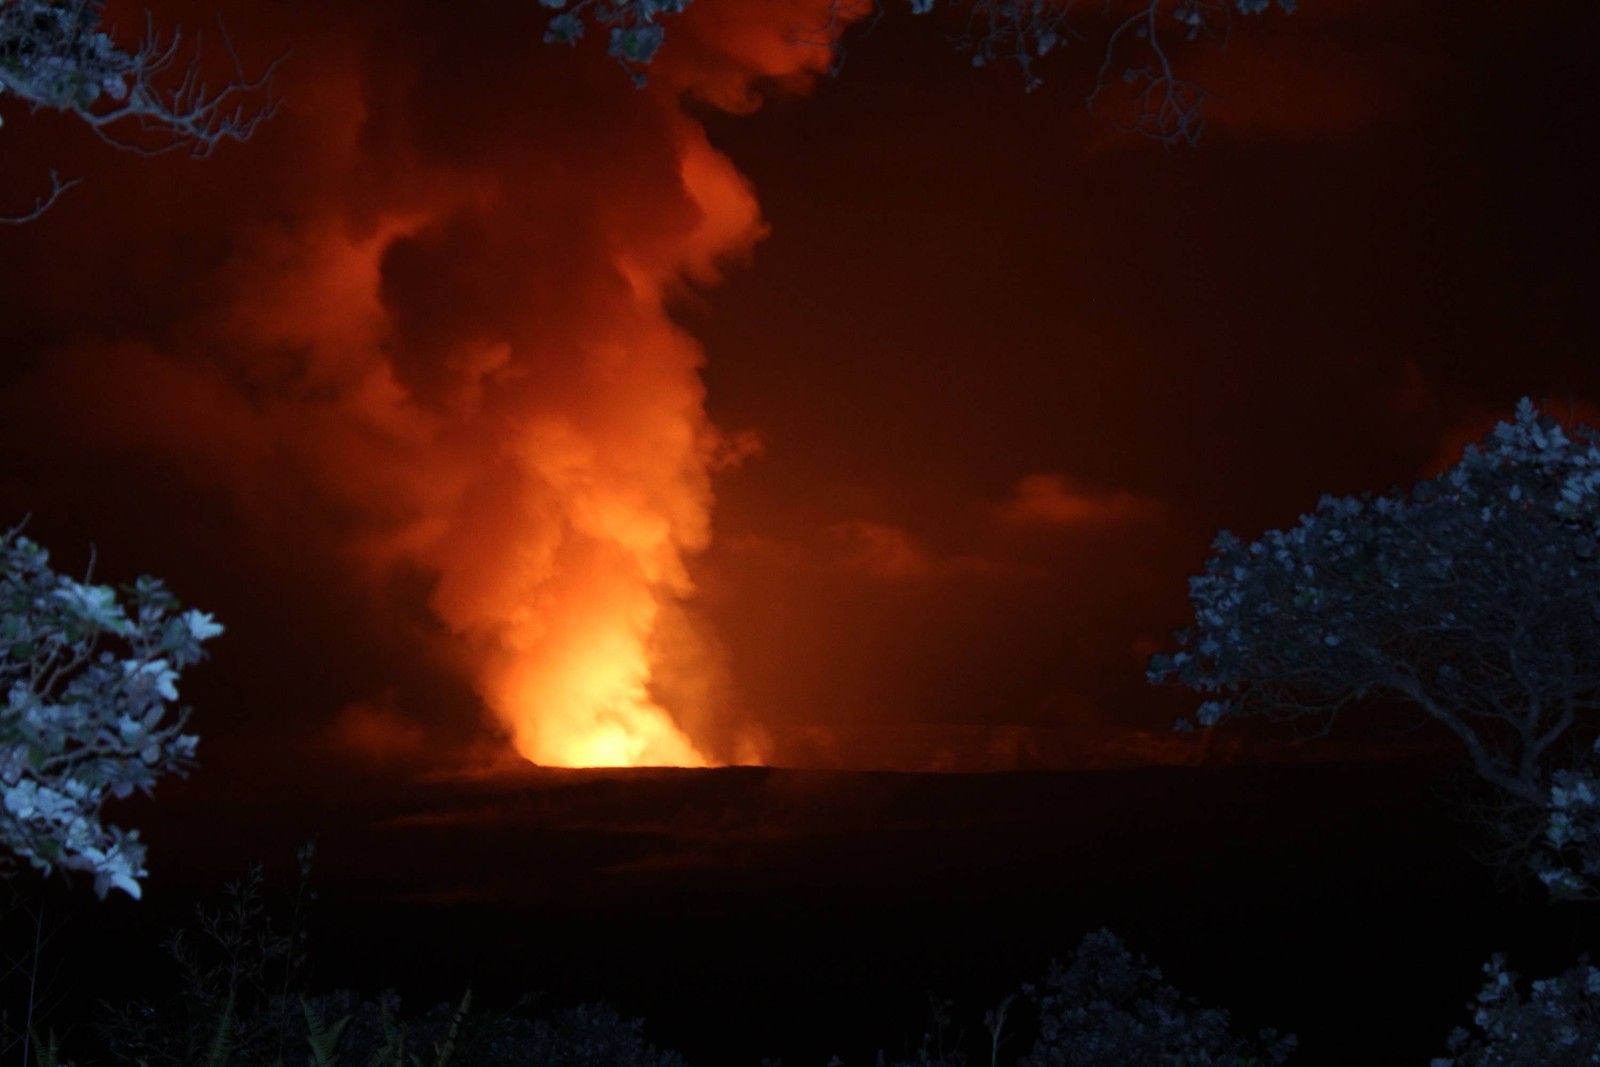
[1149,398,1600,897]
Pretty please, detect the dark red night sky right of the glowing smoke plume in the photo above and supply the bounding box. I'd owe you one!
[678,3,1597,749]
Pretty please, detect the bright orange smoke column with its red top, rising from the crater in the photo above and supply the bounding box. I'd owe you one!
[380,0,864,766]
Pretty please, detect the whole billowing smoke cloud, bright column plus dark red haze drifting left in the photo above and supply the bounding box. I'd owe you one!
[6,0,851,765]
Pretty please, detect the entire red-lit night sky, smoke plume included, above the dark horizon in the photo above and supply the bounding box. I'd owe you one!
[0,0,1600,776]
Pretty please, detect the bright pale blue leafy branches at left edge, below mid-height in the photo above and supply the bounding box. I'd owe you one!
[0,530,222,899]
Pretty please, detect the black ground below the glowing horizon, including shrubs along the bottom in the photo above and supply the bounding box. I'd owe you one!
[0,765,1600,1067]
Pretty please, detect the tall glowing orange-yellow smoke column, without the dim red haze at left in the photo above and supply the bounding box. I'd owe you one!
[390,5,851,766]
